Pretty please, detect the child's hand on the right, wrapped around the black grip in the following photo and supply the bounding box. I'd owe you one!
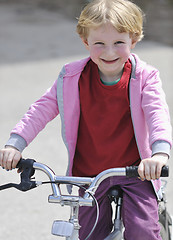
[138,153,168,181]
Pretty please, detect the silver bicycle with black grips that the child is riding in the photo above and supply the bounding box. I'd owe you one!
[0,159,172,240]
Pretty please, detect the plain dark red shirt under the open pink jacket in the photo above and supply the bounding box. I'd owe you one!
[73,60,139,176]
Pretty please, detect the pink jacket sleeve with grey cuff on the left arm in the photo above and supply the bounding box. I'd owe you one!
[6,81,59,151]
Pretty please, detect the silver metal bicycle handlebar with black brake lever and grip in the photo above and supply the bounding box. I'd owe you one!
[0,159,169,206]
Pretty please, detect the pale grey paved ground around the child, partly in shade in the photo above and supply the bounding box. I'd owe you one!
[0,4,173,240]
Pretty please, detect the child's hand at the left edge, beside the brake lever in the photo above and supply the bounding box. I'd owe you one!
[0,146,22,170]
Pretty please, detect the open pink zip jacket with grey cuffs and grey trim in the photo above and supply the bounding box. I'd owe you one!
[7,54,172,199]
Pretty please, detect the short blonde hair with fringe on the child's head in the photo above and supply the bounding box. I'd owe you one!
[77,0,144,42]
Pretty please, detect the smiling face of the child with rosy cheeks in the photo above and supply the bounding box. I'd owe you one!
[83,23,136,79]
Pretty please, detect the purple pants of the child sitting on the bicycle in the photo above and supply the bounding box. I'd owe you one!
[79,177,162,240]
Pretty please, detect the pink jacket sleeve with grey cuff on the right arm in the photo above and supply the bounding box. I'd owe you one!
[142,69,172,152]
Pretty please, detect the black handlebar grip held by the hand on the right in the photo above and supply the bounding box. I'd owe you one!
[126,166,169,177]
